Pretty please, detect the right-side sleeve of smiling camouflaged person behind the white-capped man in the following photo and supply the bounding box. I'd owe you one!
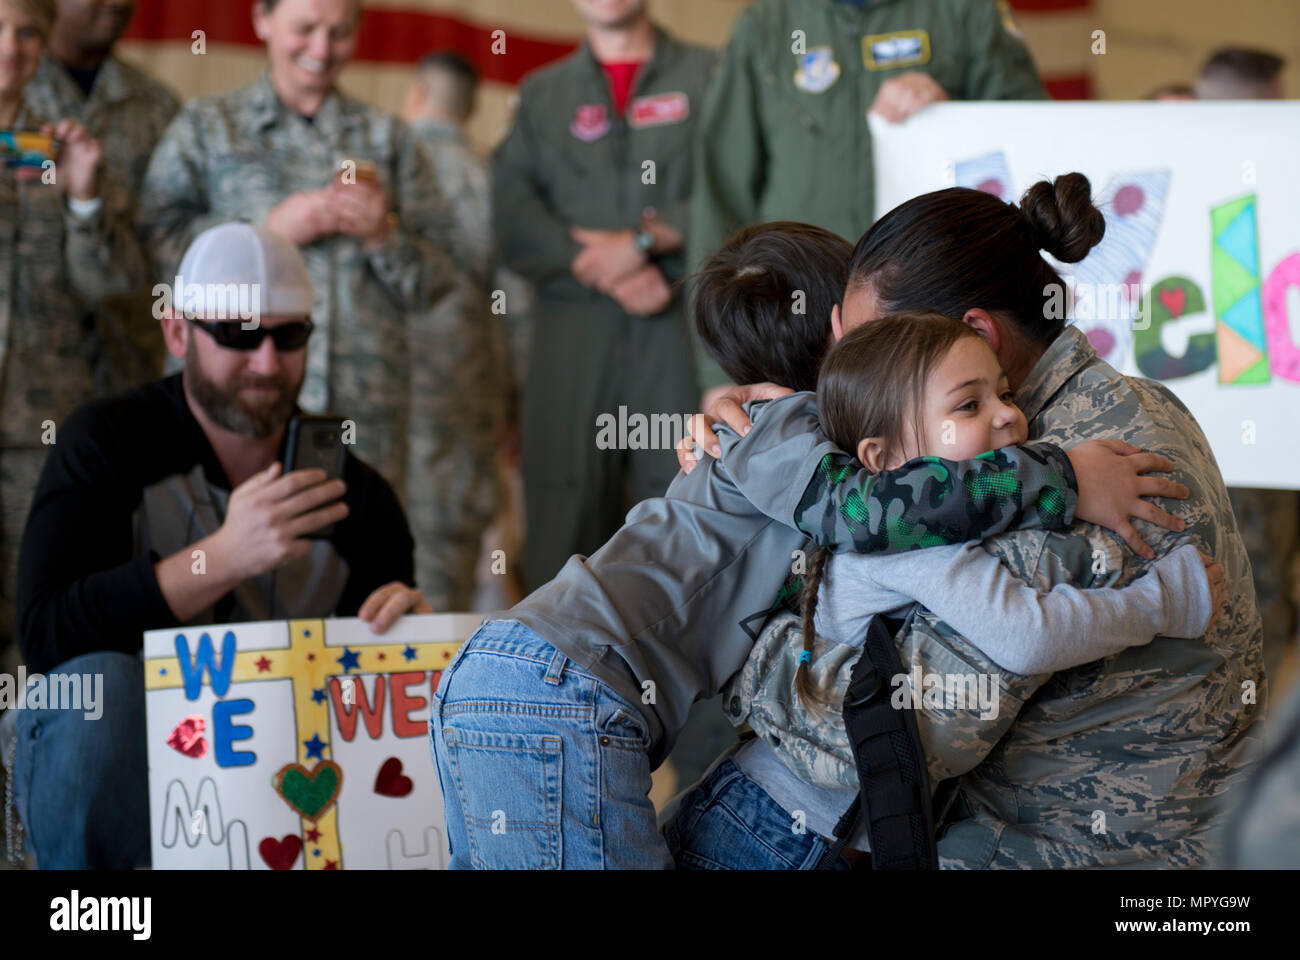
[369,115,462,310]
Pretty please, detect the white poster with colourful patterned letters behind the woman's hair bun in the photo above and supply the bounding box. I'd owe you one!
[871,101,1300,489]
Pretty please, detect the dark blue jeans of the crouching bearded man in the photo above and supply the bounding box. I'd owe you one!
[13,650,150,870]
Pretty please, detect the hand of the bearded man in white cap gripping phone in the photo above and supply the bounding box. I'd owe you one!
[209,462,347,581]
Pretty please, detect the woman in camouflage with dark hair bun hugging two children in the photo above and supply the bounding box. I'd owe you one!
[680,174,1266,869]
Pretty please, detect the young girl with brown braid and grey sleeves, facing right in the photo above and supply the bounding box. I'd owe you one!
[670,312,1223,866]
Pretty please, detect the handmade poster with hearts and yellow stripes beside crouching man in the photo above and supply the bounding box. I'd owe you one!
[144,614,482,870]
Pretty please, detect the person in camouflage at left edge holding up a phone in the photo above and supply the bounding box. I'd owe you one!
[0,0,144,649]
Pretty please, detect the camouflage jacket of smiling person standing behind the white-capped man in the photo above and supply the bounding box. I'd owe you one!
[139,73,455,502]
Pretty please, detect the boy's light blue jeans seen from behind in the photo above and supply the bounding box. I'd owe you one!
[429,620,672,870]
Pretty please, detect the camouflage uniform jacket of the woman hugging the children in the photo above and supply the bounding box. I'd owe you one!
[717,327,1265,868]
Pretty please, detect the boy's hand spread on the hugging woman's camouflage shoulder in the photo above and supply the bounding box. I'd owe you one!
[1066,440,1191,559]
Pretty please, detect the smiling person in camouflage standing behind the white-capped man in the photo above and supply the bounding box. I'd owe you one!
[139,0,473,601]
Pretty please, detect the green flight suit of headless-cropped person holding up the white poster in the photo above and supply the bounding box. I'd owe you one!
[688,0,1045,388]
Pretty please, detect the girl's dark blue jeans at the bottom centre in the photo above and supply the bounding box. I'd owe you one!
[663,747,853,870]
